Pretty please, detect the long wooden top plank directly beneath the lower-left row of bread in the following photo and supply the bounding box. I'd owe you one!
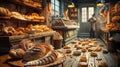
[0,31,55,42]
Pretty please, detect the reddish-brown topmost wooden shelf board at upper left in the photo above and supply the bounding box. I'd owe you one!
[8,0,42,10]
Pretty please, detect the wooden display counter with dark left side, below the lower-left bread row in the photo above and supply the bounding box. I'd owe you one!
[0,31,55,53]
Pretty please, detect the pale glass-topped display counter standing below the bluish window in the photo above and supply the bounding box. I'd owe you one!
[52,18,79,46]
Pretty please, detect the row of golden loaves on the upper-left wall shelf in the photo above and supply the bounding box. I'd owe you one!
[0,7,45,22]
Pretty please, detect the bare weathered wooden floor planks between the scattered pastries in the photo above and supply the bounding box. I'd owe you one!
[58,38,119,67]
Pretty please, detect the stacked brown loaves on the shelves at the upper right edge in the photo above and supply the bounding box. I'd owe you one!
[106,1,120,31]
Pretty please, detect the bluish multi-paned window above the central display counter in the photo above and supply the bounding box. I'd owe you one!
[51,0,60,16]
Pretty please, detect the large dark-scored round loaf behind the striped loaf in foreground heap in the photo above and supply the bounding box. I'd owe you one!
[23,43,53,61]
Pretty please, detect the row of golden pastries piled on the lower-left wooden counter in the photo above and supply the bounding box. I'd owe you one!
[1,24,52,36]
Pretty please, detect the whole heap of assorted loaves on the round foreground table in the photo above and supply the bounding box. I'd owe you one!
[9,39,58,66]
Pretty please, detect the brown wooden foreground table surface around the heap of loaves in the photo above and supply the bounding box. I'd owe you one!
[0,51,66,67]
